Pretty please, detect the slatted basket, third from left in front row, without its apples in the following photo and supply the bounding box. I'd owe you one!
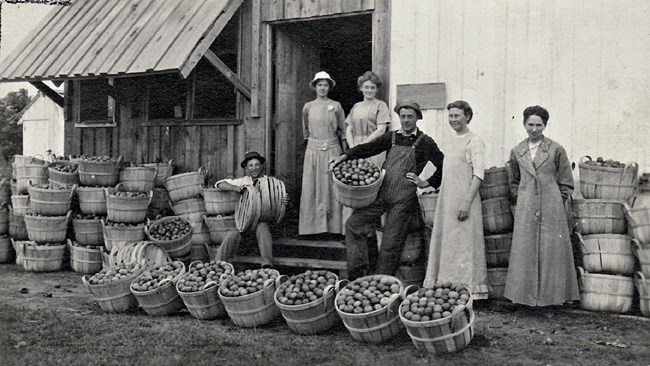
[176,262,235,320]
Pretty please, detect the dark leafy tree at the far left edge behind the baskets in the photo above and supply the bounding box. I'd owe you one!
[0,89,30,161]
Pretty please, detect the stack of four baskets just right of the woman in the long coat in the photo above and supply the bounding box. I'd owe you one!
[573,157,638,313]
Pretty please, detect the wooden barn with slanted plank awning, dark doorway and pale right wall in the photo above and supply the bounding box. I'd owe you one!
[0,0,650,197]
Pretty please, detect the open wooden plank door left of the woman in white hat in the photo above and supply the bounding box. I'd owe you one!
[273,29,320,212]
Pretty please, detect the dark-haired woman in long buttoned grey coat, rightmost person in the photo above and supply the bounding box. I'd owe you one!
[505,106,579,306]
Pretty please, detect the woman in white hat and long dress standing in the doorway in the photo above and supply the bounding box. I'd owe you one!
[298,71,347,235]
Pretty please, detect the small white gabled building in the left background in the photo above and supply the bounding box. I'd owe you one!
[19,92,64,157]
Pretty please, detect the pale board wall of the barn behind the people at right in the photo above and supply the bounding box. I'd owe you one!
[390,0,650,172]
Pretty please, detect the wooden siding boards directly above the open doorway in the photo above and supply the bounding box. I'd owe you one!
[262,0,375,22]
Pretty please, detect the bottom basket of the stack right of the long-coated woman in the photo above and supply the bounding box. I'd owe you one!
[578,267,634,313]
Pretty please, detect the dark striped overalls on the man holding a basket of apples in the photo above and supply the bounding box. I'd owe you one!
[345,132,424,275]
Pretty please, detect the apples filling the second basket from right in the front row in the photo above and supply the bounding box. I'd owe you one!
[336,275,402,314]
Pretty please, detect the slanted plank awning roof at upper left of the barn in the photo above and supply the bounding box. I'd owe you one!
[0,0,243,80]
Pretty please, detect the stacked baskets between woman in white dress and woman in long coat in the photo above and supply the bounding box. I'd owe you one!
[479,167,514,299]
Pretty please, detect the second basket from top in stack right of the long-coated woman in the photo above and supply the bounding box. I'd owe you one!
[572,199,627,235]
